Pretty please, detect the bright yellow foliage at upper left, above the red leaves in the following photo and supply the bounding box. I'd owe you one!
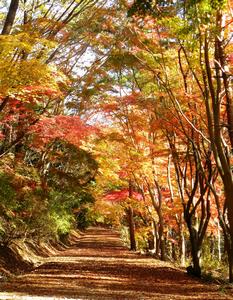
[0,32,62,95]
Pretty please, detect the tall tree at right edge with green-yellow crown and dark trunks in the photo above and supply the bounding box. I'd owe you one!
[124,1,232,281]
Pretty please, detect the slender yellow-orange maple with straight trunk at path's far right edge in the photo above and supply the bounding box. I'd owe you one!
[93,86,173,259]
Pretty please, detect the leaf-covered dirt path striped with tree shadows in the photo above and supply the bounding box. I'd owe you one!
[0,228,233,300]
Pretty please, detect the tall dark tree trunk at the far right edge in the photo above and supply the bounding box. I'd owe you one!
[204,10,233,282]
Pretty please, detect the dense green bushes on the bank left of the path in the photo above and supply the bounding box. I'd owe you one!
[0,145,97,243]
